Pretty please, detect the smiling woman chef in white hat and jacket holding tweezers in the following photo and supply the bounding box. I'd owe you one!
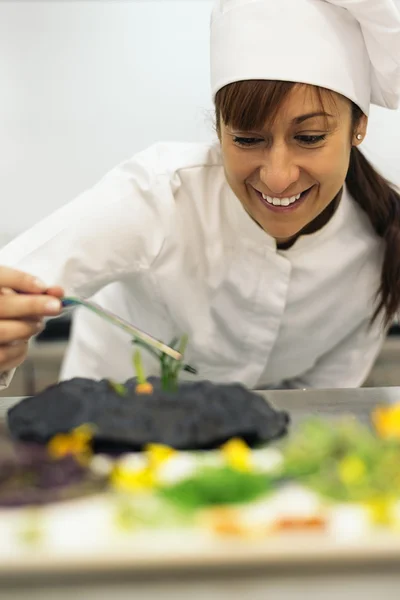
[0,0,400,388]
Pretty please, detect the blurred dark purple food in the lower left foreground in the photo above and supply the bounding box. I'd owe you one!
[0,432,106,508]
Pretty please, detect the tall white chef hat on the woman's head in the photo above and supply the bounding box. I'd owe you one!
[211,0,400,114]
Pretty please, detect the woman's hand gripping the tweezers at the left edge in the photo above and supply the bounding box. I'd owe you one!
[0,266,64,373]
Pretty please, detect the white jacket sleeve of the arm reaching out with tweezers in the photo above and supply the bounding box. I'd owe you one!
[0,151,174,388]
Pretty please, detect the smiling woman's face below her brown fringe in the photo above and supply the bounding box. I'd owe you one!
[220,85,367,241]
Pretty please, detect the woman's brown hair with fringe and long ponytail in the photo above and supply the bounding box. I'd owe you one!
[215,80,400,326]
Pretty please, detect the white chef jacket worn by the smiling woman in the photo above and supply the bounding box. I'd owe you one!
[0,143,385,388]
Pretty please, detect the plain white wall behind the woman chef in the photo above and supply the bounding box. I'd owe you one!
[0,0,400,245]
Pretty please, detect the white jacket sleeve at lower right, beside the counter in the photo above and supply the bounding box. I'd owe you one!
[285,318,386,389]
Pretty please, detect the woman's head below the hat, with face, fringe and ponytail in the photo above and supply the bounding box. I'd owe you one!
[215,80,400,325]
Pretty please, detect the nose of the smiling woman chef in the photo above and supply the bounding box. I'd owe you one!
[260,144,300,195]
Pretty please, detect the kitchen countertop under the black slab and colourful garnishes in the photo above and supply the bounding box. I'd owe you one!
[0,387,400,600]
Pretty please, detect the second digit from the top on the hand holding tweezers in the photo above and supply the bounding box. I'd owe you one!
[0,294,62,319]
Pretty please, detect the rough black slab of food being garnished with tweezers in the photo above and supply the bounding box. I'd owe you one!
[8,377,289,453]
